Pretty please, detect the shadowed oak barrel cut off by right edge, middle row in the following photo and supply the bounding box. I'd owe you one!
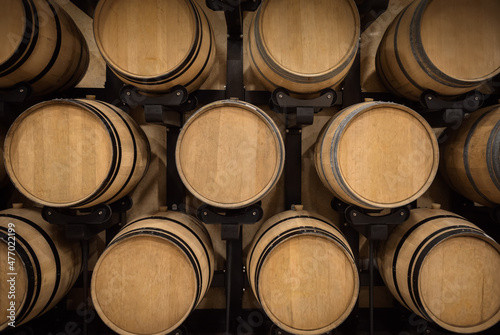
[440,105,500,207]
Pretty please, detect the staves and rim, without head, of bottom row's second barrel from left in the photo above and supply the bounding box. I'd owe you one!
[91,210,215,335]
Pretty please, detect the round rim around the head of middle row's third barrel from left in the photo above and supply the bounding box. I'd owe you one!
[318,101,439,208]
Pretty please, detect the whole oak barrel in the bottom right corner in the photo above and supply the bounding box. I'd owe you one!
[377,208,500,333]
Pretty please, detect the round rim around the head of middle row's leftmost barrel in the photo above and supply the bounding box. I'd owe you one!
[4,99,114,207]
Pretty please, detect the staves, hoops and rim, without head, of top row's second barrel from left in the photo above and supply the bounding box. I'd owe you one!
[94,0,216,94]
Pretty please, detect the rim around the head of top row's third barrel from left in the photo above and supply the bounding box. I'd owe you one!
[249,0,361,79]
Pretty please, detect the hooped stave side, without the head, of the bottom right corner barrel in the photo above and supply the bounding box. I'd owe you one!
[376,208,500,334]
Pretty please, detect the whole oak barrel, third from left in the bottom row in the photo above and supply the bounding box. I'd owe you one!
[247,210,359,334]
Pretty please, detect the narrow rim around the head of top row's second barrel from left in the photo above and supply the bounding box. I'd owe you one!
[93,0,199,81]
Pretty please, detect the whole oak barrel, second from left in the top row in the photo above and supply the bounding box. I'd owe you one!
[94,0,215,93]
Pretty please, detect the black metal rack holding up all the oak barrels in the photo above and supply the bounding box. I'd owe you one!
[0,0,500,335]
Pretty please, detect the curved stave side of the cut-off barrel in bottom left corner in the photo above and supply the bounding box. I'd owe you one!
[0,208,82,330]
